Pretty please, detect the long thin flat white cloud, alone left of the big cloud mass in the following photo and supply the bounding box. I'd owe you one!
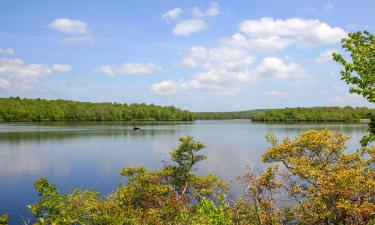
[94,63,162,76]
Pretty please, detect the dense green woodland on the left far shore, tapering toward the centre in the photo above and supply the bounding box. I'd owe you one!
[0,97,194,122]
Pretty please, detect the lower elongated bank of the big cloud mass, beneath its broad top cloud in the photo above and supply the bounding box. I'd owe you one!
[151,57,307,95]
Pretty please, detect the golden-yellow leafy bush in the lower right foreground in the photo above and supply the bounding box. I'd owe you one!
[263,130,375,224]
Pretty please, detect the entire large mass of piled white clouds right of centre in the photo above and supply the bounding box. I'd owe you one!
[152,16,346,95]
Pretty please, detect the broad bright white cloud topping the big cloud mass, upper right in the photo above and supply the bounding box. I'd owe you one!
[239,18,347,47]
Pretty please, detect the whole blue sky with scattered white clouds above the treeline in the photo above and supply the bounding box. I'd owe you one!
[0,0,375,111]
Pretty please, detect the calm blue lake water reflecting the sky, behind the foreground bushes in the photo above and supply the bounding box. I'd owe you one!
[0,120,367,224]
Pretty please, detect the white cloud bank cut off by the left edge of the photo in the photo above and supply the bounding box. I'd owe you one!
[0,58,71,89]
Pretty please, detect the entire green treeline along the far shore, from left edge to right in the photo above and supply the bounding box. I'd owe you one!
[0,97,375,122]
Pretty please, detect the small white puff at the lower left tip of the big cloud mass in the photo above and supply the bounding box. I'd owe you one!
[151,80,189,95]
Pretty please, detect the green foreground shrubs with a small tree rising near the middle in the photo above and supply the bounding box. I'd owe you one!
[29,137,231,224]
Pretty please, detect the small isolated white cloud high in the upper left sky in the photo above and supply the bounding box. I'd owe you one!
[48,18,89,35]
